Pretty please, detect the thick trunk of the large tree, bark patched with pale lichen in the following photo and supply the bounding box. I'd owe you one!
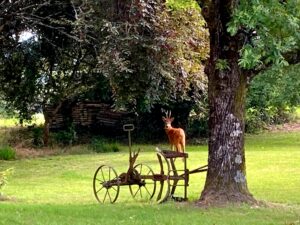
[199,1,254,205]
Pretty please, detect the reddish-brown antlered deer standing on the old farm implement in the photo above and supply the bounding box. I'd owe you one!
[162,112,185,152]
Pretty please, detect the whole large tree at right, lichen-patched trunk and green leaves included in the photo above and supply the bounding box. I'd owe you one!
[197,0,300,205]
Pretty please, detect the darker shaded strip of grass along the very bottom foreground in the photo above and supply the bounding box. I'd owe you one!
[0,203,299,225]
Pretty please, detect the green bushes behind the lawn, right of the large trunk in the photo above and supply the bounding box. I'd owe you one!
[246,64,300,132]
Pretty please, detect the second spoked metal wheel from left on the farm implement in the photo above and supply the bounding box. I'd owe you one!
[129,164,156,201]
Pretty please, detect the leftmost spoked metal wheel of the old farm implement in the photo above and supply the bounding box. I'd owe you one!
[93,165,120,203]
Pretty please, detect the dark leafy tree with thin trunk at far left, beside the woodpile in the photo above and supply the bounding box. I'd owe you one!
[0,0,101,145]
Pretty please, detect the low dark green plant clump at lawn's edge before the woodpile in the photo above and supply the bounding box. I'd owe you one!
[90,137,120,153]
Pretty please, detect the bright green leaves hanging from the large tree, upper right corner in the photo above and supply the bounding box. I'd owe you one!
[228,0,300,69]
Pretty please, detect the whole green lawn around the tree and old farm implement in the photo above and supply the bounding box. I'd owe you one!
[0,132,300,225]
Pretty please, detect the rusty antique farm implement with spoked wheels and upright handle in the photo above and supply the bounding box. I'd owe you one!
[93,124,207,203]
